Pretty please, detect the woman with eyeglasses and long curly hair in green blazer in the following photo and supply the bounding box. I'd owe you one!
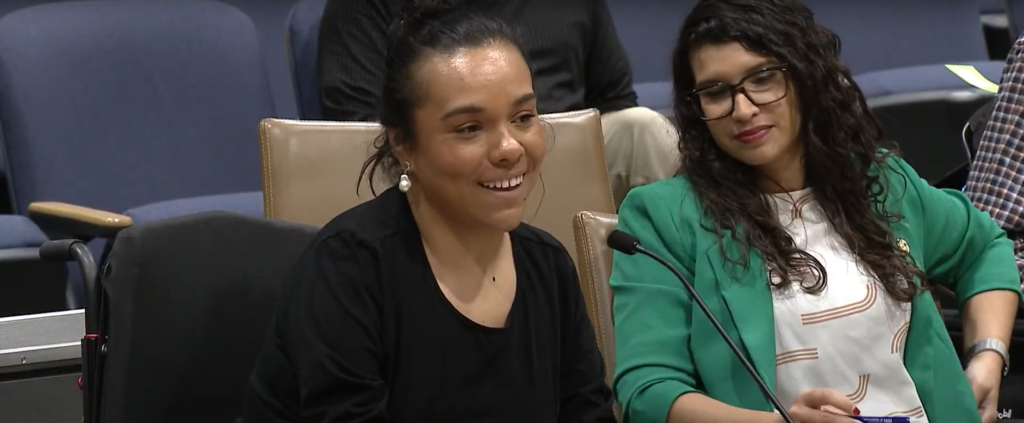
[611,0,1020,423]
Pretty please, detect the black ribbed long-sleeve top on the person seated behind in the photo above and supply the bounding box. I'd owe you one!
[317,0,637,121]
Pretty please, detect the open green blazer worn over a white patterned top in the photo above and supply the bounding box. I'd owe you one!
[610,158,1020,423]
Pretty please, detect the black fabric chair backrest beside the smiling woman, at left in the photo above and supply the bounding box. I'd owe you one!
[100,212,317,423]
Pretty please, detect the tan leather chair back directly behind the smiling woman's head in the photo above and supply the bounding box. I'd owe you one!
[260,110,614,259]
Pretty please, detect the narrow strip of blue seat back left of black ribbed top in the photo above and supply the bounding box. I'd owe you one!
[288,0,327,120]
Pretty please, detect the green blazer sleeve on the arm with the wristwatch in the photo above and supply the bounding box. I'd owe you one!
[893,159,1020,307]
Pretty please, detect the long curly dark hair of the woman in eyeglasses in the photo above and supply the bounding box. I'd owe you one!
[672,0,925,302]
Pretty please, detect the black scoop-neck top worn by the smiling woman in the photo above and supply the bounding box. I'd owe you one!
[244,188,614,423]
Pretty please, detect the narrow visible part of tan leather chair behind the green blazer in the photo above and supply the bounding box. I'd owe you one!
[572,211,622,421]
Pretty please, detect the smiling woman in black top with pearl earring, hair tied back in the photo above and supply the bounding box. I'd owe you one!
[245,1,614,423]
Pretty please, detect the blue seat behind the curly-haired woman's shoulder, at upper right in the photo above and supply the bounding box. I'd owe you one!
[803,0,1002,182]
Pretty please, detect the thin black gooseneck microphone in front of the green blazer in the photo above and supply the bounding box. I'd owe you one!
[607,229,796,423]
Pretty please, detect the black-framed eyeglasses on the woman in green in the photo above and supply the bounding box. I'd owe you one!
[687,65,790,121]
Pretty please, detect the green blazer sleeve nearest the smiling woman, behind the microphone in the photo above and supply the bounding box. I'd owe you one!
[610,178,699,423]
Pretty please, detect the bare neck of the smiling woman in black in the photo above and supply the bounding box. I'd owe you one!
[407,192,507,272]
